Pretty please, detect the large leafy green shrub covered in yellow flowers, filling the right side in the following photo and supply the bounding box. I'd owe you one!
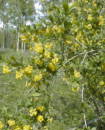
[3,0,105,130]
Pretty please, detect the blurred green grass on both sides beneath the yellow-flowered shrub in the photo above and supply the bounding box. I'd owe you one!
[0,50,93,130]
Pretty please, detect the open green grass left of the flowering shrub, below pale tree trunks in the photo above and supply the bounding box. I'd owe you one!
[0,50,27,118]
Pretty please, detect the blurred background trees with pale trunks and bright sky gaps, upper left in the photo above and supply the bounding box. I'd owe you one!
[0,0,74,51]
